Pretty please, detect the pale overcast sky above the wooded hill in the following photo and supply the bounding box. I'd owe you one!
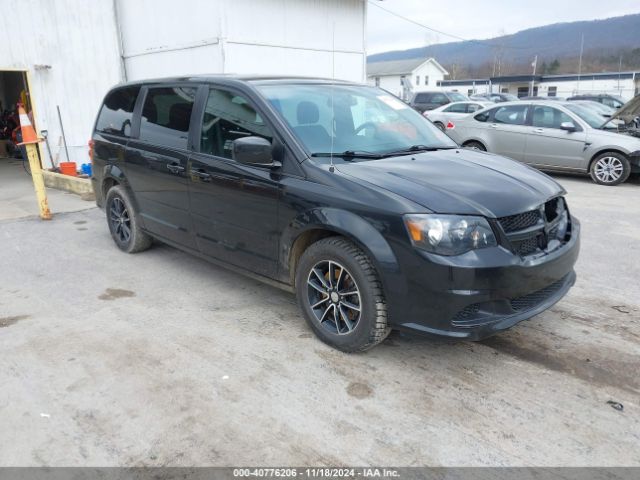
[367,0,640,54]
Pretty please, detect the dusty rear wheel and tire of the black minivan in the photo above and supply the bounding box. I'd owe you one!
[105,185,153,253]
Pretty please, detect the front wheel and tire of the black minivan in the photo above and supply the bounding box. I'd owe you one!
[296,237,391,352]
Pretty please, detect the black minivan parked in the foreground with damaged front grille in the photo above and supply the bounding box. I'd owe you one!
[91,76,580,351]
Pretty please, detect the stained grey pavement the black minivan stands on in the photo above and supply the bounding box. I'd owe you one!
[0,172,640,466]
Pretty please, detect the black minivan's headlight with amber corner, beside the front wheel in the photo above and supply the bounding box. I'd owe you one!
[404,214,498,255]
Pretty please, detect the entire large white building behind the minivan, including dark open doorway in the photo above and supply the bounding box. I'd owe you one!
[0,0,367,169]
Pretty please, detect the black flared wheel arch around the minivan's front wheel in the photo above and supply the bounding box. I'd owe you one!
[279,207,406,322]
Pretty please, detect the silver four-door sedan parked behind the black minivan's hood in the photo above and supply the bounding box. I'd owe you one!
[447,101,640,185]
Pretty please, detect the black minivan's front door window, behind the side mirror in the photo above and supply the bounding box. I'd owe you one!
[200,88,273,158]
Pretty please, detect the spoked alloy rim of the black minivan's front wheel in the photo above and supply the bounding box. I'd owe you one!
[307,260,362,335]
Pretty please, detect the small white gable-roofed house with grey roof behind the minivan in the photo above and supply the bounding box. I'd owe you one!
[367,58,449,100]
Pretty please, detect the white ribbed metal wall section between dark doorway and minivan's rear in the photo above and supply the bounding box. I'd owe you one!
[0,0,121,167]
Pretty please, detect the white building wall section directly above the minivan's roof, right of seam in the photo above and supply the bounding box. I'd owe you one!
[117,0,366,81]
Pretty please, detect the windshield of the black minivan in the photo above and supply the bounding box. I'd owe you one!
[252,84,457,159]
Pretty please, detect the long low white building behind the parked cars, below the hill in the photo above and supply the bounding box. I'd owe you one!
[440,72,640,100]
